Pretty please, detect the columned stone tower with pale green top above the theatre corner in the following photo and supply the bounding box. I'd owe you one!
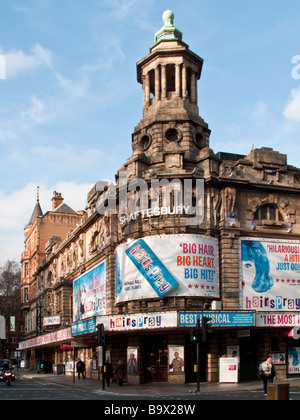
[124,10,210,178]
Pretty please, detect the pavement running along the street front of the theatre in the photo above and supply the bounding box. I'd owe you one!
[16,368,300,398]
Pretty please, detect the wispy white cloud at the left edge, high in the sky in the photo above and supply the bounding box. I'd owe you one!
[0,44,53,78]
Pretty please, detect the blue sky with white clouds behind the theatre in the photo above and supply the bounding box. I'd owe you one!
[0,0,300,264]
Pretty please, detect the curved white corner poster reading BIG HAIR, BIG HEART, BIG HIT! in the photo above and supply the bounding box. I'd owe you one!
[116,235,219,303]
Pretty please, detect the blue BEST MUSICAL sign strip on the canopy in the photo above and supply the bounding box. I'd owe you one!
[178,311,255,327]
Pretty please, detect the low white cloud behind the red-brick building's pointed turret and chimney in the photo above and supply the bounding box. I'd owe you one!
[0,181,93,265]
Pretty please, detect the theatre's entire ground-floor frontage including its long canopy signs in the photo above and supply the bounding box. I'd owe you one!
[19,310,300,384]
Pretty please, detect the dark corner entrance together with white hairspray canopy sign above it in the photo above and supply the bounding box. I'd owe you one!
[97,311,184,383]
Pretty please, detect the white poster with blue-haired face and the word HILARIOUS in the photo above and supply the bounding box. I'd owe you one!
[240,238,300,312]
